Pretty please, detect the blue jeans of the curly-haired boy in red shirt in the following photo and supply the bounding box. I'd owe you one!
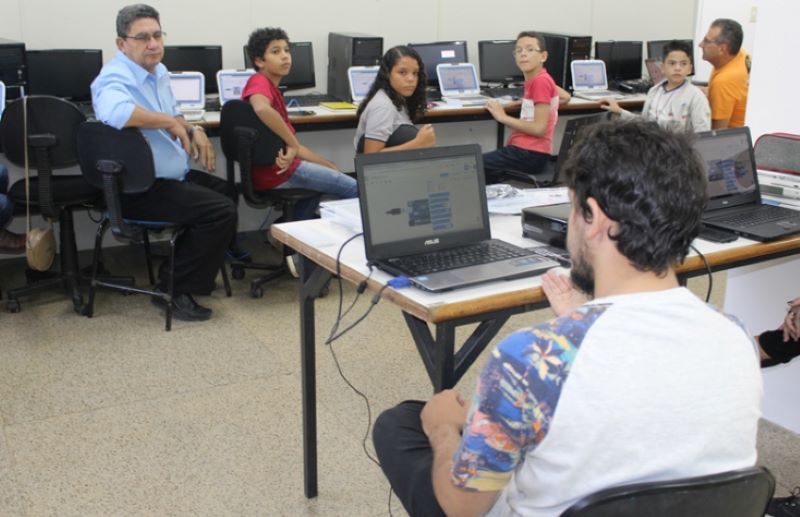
[277,160,358,221]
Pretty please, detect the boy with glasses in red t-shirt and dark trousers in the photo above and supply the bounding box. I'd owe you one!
[483,31,569,183]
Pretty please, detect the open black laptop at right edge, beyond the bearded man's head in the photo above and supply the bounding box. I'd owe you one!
[695,127,800,241]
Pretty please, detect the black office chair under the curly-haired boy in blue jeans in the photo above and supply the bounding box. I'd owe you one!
[220,100,322,298]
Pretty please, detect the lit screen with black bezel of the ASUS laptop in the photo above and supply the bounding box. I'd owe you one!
[356,145,491,260]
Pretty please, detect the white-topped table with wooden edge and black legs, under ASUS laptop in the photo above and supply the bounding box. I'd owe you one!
[271,216,800,497]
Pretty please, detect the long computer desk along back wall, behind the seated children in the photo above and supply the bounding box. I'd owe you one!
[199,95,645,147]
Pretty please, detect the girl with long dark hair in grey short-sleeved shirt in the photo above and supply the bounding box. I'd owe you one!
[353,45,436,153]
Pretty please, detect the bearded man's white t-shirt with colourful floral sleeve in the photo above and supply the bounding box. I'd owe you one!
[452,288,762,516]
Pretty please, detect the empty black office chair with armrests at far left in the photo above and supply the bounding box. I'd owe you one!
[0,95,100,313]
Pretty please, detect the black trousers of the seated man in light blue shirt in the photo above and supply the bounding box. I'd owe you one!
[122,171,236,295]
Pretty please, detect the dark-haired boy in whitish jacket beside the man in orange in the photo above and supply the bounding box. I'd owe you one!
[600,40,711,131]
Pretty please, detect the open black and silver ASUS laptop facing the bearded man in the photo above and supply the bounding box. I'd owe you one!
[355,144,558,292]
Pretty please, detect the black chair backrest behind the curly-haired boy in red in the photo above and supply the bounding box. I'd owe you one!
[220,100,284,206]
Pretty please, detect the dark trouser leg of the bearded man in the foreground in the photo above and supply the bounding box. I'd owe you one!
[372,400,444,517]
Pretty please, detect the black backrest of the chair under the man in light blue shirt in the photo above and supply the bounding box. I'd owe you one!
[77,122,156,240]
